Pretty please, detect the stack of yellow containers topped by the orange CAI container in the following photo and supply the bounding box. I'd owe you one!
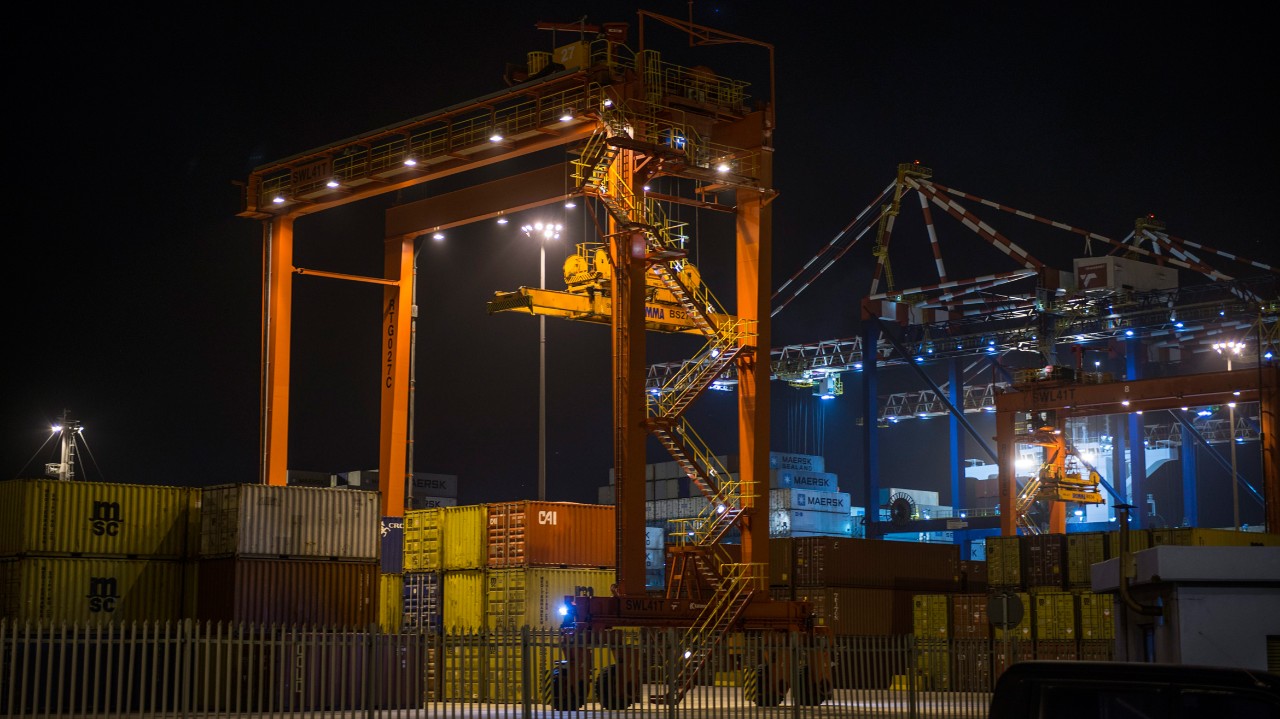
[402,500,616,702]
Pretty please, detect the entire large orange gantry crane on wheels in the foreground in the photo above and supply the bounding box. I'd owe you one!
[239,12,832,710]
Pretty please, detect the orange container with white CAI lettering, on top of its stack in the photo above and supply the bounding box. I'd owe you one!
[488,502,617,569]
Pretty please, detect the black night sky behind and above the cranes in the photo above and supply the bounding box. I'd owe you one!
[0,1,1280,511]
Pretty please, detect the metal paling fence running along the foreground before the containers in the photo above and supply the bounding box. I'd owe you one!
[0,620,1108,719]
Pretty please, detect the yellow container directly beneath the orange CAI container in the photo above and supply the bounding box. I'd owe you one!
[486,567,617,631]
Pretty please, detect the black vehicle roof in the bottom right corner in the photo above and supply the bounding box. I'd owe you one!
[988,660,1280,719]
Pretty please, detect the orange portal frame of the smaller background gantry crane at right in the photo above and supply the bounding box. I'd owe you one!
[996,366,1280,535]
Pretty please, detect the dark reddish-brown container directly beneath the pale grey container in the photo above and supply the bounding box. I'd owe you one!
[196,555,381,627]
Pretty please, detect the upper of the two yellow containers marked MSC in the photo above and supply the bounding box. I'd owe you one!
[0,478,196,559]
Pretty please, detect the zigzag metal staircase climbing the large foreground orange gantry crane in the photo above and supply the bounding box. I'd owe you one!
[573,95,765,704]
